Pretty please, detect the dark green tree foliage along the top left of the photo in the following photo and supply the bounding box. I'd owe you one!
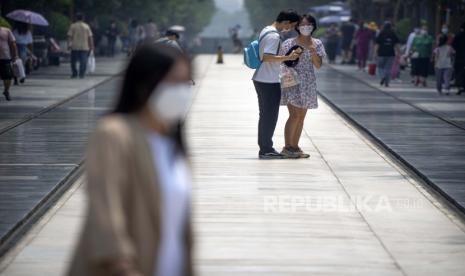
[0,0,215,38]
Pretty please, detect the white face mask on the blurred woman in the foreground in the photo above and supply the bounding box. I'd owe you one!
[149,83,194,127]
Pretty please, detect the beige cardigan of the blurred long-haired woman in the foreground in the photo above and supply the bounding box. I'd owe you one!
[68,115,193,276]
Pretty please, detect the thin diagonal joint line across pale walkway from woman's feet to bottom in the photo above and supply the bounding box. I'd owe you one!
[304,124,407,276]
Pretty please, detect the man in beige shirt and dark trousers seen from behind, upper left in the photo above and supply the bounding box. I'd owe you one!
[68,13,94,79]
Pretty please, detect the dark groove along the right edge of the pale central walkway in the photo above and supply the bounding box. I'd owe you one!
[318,86,465,218]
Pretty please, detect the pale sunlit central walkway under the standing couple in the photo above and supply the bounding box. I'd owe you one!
[0,55,465,276]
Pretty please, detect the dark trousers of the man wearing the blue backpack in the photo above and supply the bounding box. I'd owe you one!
[253,81,281,154]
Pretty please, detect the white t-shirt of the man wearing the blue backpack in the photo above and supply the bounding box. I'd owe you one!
[252,26,281,83]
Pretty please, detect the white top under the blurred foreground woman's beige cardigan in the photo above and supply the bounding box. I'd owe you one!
[148,133,190,276]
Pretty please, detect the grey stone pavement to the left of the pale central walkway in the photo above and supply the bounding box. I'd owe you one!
[0,56,124,250]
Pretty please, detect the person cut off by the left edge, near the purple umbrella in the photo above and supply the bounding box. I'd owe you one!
[0,27,18,101]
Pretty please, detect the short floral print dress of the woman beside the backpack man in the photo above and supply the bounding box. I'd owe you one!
[280,38,326,109]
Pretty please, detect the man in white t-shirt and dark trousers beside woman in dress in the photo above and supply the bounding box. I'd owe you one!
[252,10,300,159]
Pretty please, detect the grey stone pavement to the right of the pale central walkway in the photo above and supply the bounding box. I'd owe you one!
[320,66,465,212]
